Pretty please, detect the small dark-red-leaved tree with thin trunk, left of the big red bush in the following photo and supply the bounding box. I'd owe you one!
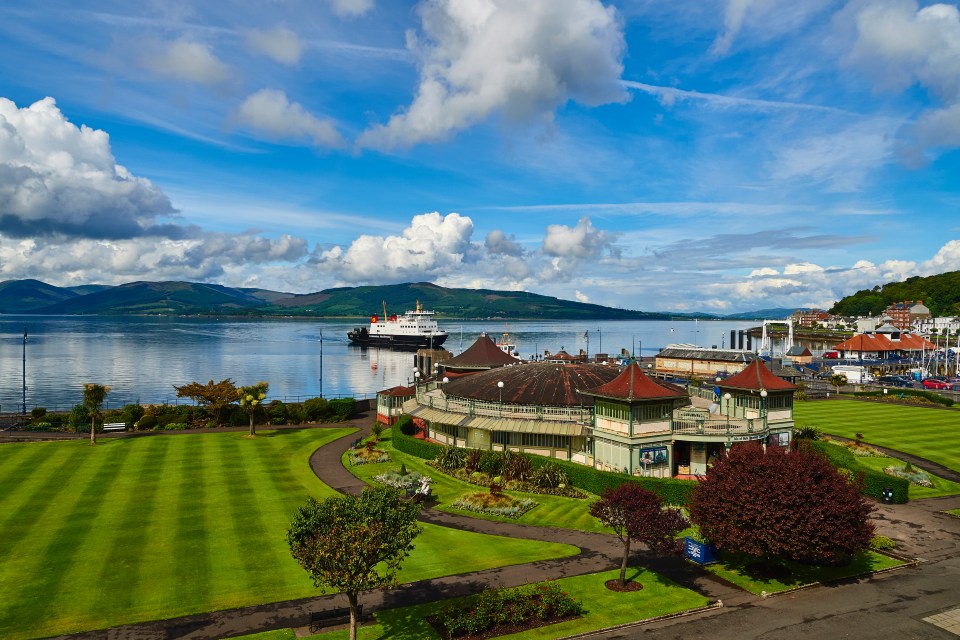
[590,482,689,586]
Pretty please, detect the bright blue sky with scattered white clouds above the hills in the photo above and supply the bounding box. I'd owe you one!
[0,0,960,313]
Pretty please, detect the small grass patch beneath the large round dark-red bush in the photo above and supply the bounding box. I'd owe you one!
[704,551,904,595]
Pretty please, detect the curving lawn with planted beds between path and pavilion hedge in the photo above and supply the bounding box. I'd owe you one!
[344,432,604,532]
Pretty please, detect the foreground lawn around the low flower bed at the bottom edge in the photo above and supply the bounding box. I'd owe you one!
[302,568,710,640]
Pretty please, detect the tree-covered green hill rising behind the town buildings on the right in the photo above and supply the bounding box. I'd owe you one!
[830,271,960,316]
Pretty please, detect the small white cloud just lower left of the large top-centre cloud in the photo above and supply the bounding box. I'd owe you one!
[234,89,344,147]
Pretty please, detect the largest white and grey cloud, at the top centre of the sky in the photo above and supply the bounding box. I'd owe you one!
[358,0,627,149]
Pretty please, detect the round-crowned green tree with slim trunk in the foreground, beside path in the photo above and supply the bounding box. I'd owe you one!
[287,487,420,640]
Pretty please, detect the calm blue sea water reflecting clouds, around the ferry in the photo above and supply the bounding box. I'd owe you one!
[0,316,757,412]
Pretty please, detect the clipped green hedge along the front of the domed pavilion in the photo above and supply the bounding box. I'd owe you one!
[391,424,697,506]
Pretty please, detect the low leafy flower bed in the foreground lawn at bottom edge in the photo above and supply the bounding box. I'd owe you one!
[427,582,583,638]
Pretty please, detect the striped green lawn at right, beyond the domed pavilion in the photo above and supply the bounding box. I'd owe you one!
[794,400,960,471]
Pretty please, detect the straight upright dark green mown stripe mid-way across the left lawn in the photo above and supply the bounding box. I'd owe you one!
[170,434,216,608]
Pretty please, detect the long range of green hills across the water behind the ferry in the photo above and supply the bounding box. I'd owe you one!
[0,280,676,320]
